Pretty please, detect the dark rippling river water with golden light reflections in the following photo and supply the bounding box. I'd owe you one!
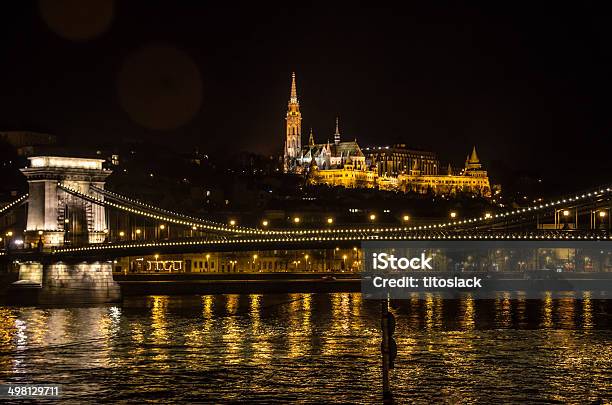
[0,293,612,403]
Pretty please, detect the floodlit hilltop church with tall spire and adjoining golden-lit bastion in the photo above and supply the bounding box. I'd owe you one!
[283,73,491,197]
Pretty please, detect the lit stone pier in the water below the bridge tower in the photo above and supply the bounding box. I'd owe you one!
[8,261,121,305]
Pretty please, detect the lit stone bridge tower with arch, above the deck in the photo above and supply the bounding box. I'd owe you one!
[21,156,111,246]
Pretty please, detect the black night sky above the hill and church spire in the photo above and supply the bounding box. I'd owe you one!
[0,0,612,185]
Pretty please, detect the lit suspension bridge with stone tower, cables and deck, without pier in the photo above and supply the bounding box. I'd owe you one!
[0,157,612,260]
